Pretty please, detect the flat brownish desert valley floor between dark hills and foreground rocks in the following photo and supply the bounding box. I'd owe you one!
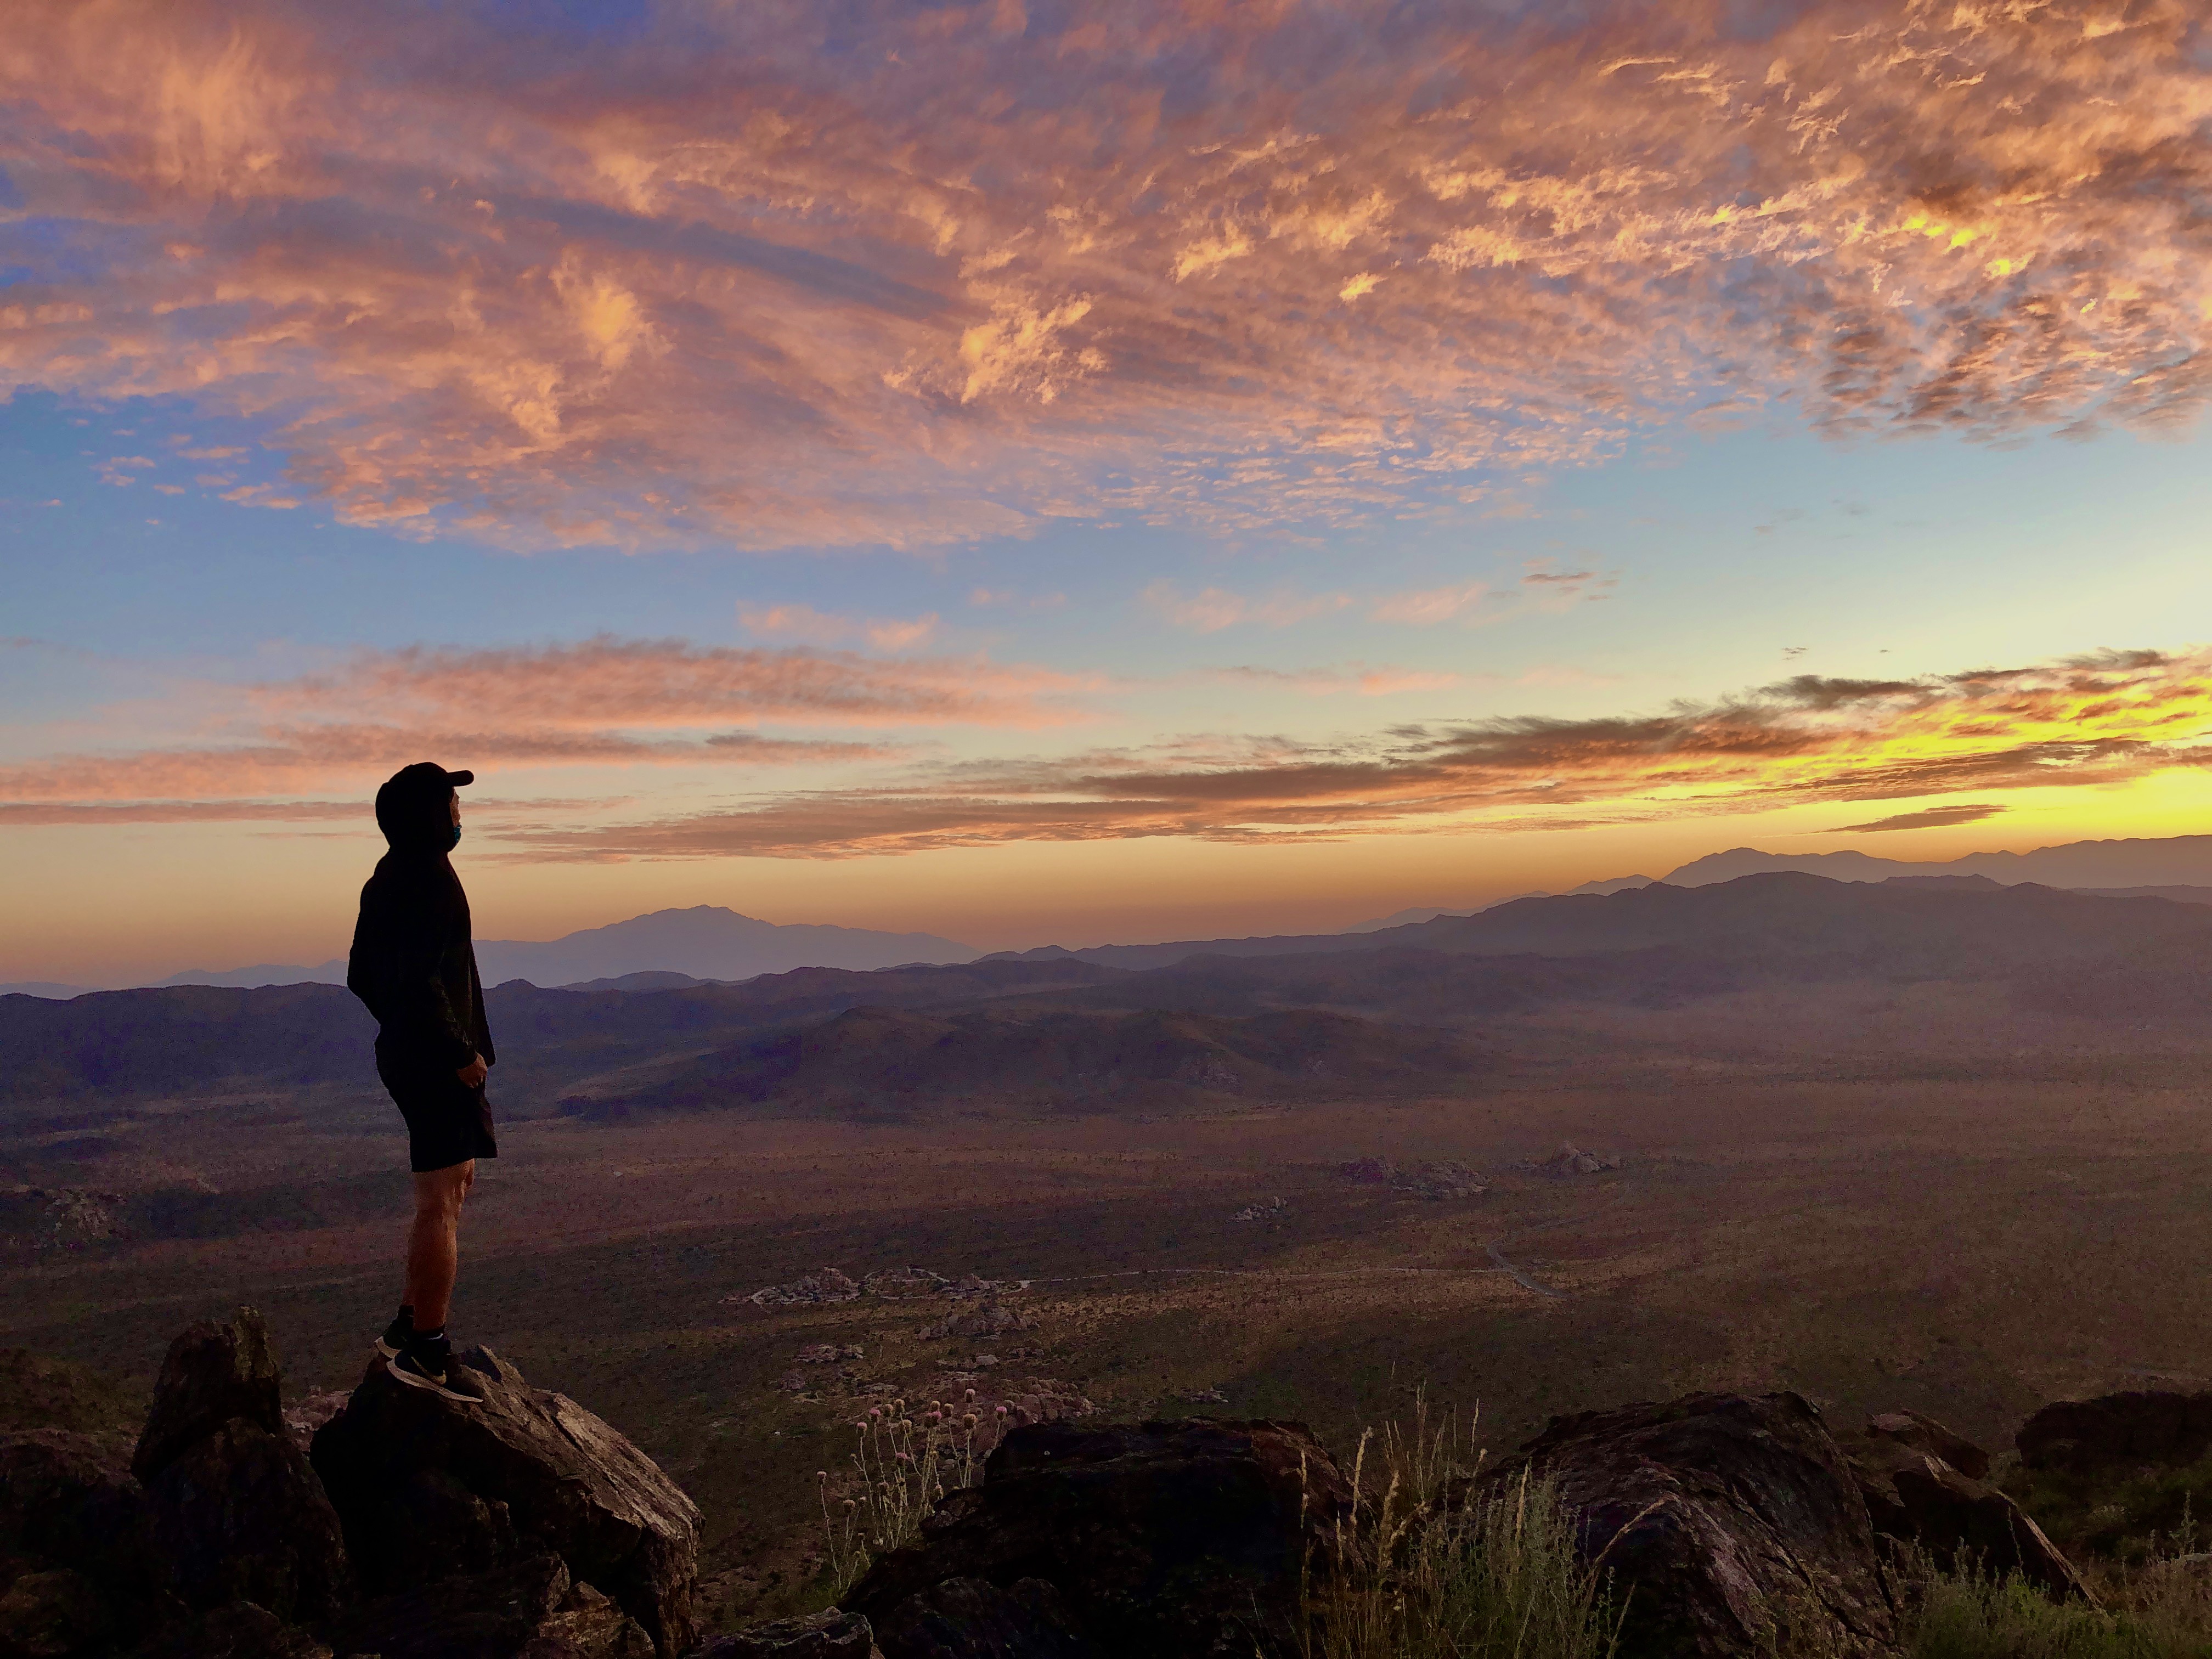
[0,984,2212,1619]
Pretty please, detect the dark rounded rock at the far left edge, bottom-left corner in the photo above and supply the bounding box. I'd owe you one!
[0,1429,184,1637]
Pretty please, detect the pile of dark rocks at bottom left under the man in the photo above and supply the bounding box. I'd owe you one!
[0,1310,699,1659]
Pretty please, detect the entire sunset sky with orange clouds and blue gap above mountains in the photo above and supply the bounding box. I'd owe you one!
[0,0,2212,984]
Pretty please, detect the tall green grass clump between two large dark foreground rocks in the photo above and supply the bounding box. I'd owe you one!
[1303,1407,1619,1659]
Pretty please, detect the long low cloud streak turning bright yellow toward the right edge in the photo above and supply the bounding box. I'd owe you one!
[475,650,2212,858]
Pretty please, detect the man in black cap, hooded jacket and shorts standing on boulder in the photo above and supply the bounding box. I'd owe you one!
[345,761,500,1402]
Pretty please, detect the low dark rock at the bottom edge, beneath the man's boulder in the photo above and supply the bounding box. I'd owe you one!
[328,1555,652,1659]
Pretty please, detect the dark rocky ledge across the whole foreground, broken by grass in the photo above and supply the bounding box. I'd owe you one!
[0,1310,2159,1659]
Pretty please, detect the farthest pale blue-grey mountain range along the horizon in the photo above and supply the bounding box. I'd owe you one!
[17,836,2212,997]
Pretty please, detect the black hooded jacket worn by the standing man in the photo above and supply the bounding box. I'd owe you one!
[345,792,495,1073]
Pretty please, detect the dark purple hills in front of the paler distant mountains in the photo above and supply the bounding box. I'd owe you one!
[13,872,2212,1132]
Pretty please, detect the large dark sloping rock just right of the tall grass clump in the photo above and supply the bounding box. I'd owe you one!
[1487,1393,1898,1659]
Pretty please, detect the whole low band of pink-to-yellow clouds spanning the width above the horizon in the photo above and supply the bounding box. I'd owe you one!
[0,639,2212,862]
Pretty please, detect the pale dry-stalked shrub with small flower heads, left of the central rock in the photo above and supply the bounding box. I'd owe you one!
[819,1389,1005,1599]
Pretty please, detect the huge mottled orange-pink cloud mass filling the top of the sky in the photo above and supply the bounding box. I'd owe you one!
[0,0,2212,546]
